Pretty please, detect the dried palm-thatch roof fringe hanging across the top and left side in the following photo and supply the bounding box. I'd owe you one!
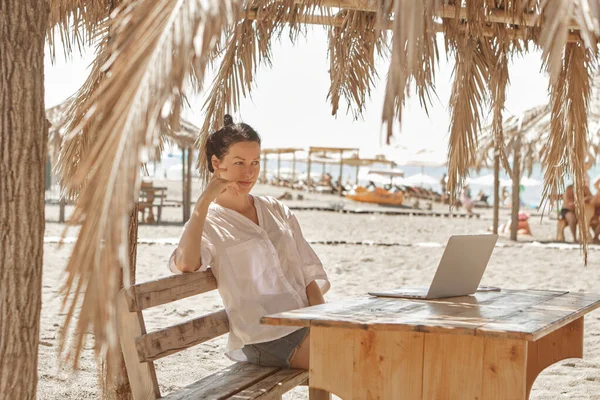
[50,0,600,368]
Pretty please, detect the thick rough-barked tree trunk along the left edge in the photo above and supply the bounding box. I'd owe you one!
[0,0,48,399]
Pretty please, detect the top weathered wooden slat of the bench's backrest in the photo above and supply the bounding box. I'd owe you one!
[127,270,217,311]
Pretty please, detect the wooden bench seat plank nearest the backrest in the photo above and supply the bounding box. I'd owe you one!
[162,363,279,400]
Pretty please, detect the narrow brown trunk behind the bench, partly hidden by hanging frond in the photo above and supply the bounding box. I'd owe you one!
[100,203,138,400]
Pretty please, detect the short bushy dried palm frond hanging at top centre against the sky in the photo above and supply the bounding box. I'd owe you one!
[327,11,385,119]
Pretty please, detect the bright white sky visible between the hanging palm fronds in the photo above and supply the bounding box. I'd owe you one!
[45,27,548,156]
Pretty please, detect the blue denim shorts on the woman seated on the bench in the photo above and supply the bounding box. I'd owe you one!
[242,328,309,368]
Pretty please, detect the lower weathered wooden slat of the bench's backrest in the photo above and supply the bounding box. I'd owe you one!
[135,310,229,362]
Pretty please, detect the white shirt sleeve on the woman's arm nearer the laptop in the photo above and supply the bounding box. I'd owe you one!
[286,214,331,294]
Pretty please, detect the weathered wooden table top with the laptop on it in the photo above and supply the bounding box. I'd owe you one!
[261,290,600,341]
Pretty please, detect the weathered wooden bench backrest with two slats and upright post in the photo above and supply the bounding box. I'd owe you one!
[119,270,229,400]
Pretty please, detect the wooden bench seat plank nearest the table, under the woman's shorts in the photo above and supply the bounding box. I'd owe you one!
[231,369,308,400]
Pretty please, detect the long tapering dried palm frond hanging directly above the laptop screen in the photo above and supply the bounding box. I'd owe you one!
[447,32,491,203]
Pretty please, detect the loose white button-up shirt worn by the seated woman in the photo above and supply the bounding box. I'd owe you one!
[169,196,330,361]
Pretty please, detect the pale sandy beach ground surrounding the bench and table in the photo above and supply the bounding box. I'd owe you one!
[38,181,600,400]
